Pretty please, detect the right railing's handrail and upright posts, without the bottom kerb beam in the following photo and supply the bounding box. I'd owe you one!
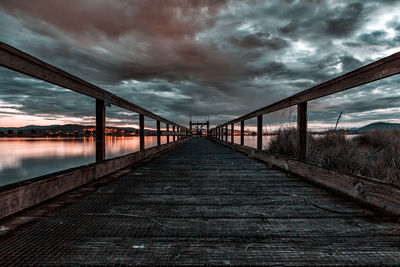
[210,52,400,161]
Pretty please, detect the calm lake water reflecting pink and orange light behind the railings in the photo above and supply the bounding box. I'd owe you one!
[0,136,270,186]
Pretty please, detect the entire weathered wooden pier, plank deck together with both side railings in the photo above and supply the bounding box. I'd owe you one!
[0,42,400,266]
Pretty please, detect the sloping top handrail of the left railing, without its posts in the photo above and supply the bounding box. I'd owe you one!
[0,42,181,129]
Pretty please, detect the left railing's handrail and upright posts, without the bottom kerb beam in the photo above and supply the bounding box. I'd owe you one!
[0,42,188,162]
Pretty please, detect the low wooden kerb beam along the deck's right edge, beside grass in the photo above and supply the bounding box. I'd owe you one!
[215,137,400,215]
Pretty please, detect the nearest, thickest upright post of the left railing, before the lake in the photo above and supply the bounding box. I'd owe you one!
[96,99,106,162]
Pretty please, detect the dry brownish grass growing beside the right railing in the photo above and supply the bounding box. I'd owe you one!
[267,128,400,184]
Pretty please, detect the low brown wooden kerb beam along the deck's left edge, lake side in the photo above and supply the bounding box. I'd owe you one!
[0,139,191,221]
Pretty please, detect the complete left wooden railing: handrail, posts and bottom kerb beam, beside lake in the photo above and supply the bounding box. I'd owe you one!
[0,42,190,219]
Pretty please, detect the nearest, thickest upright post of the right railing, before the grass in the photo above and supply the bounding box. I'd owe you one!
[297,102,307,161]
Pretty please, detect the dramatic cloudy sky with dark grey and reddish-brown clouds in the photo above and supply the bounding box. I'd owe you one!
[0,0,400,130]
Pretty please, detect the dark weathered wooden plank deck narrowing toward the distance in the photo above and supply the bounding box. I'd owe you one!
[0,139,400,266]
